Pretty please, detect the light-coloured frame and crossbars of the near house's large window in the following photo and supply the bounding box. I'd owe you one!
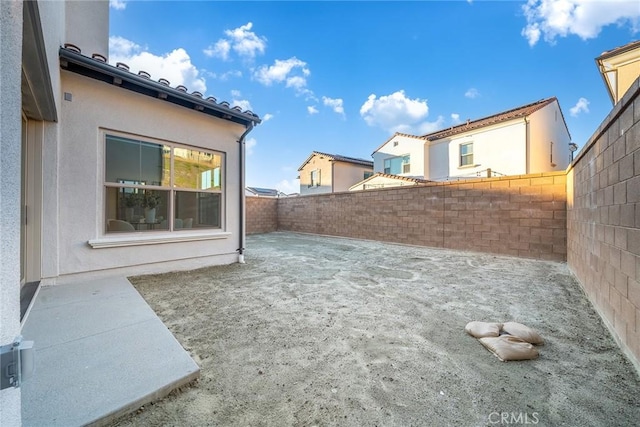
[99,129,228,238]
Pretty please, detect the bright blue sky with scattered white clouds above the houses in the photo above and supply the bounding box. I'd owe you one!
[109,0,640,193]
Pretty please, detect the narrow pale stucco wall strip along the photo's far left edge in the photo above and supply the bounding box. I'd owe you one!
[0,1,22,427]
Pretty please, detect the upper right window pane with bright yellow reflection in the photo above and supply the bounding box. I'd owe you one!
[173,148,222,190]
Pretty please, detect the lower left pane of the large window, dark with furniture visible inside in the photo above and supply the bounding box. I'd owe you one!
[105,187,169,233]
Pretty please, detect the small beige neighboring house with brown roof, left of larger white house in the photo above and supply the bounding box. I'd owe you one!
[298,151,373,196]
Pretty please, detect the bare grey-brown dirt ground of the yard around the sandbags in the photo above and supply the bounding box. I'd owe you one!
[116,233,640,427]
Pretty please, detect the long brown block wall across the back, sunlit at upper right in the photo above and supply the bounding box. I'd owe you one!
[277,172,567,261]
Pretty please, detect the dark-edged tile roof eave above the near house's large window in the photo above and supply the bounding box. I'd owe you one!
[59,44,261,126]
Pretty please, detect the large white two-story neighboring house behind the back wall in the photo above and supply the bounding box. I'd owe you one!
[373,97,571,181]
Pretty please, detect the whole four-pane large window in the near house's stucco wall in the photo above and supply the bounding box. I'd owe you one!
[105,135,224,233]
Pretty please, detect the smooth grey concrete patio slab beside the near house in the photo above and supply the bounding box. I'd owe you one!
[22,277,200,426]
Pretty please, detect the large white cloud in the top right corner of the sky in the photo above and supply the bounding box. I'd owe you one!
[521,0,640,46]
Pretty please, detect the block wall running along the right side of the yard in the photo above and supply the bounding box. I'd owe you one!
[567,80,640,370]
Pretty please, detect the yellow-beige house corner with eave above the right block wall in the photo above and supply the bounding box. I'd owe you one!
[596,40,640,105]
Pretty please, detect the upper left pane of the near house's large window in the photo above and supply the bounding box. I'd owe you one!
[105,135,169,185]
